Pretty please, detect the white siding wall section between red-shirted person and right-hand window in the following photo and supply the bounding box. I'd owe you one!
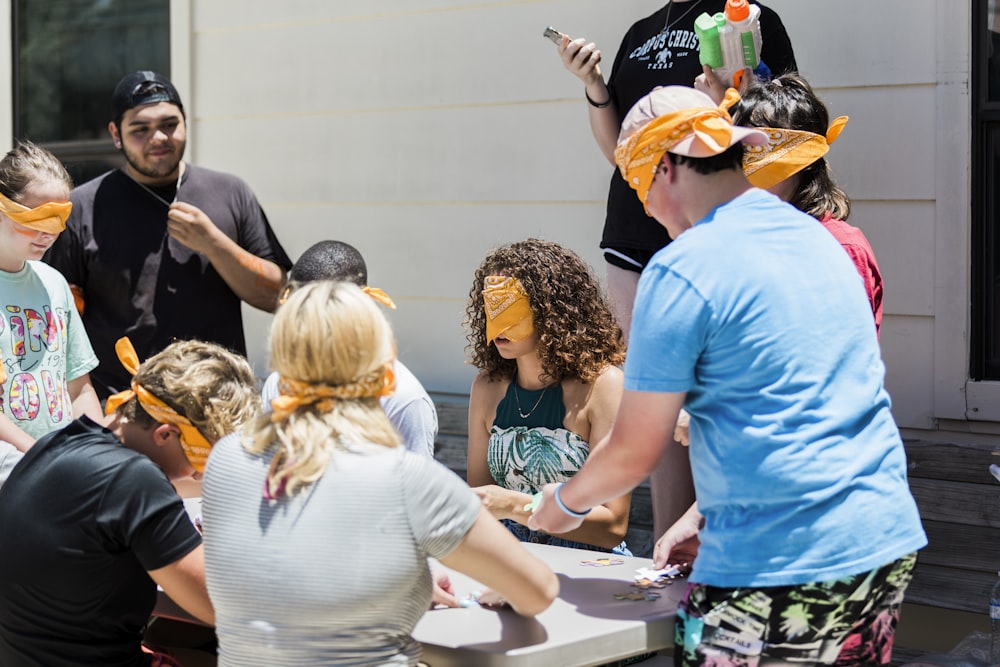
[770,0,970,429]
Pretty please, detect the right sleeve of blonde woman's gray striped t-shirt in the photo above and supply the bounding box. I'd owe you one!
[402,455,482,558]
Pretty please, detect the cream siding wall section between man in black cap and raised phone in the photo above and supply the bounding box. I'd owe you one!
[188,0,655,392]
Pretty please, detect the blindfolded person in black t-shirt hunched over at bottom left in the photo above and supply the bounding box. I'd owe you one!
[0,341,259,667]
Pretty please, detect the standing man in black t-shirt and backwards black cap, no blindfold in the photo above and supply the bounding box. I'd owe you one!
[45,71,291,400]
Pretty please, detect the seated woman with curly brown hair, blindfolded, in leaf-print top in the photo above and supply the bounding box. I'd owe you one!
[465,239,631,555]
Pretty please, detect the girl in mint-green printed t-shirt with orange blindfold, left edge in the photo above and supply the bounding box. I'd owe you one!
[0,142,102,451]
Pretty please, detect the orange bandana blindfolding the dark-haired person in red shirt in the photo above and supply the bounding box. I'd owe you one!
[743,116,847,189]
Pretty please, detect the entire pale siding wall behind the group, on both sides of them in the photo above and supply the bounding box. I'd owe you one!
[173,0,969,429]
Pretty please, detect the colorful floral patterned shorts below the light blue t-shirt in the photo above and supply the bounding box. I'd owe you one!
[674,553,917,667]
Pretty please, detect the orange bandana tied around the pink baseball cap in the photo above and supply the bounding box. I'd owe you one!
[615,88,740,206]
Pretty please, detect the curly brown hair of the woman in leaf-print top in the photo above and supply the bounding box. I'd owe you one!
[464,239,625,382]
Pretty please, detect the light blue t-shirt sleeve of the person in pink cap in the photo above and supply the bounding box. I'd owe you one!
[625,264,713,392]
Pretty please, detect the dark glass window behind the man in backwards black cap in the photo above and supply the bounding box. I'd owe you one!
[11,0,170,183]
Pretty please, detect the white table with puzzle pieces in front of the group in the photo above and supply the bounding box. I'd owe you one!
[413,543,687,667]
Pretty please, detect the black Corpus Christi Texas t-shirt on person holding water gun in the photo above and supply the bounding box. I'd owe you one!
[601,0,796,254]
